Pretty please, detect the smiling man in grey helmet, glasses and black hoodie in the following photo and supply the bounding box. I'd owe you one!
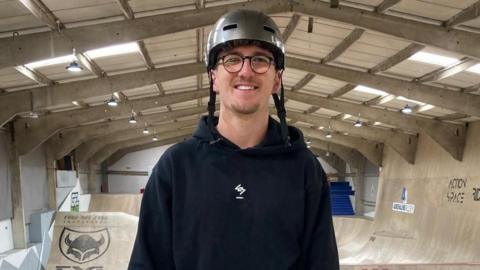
[129,10,339,270]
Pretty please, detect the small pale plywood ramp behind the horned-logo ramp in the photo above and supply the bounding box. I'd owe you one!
[88,194,142,216]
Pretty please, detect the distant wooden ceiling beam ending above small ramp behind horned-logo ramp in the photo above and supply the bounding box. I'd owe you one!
[88,128,194,164]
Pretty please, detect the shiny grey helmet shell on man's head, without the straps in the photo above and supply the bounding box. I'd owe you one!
[205,9,285,70]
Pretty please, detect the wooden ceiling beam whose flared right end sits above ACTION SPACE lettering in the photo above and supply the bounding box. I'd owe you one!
[285,91,466,161]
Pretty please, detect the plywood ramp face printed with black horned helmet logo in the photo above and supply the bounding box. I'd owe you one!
[47,212,138,270]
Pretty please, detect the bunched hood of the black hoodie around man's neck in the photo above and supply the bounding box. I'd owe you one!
[193,116,307,155]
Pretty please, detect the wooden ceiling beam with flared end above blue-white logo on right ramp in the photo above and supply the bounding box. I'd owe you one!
[288,111,418,164]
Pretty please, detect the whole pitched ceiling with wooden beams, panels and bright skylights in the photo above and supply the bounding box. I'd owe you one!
[0,0,480,166]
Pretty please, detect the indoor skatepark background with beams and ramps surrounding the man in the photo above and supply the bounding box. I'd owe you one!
[0,0,480,270]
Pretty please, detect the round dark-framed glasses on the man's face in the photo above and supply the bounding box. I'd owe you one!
[218,54,273,74]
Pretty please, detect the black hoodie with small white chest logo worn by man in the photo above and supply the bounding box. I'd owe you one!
[128,117,339,270]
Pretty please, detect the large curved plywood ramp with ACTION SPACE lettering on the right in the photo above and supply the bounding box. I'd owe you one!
[336,123,480,270]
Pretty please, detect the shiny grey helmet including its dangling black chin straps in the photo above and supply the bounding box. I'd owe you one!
[205,9,290,147]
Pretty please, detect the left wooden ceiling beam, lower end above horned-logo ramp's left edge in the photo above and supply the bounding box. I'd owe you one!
[49,107,207,159]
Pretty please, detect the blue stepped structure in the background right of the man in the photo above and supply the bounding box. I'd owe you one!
[330,182,355,216]
